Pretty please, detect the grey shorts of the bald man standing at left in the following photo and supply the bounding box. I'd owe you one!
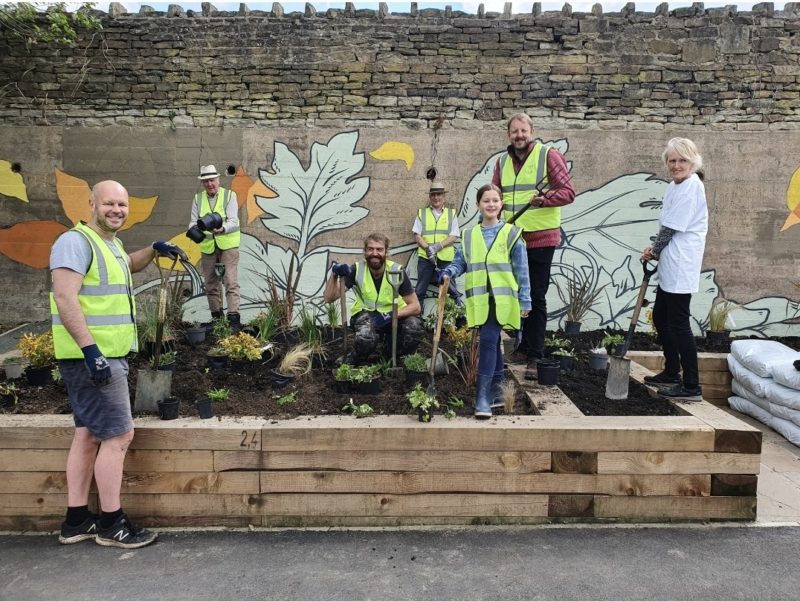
[58,358,133,440]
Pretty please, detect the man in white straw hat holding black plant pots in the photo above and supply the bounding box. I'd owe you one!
[187,165,242,332]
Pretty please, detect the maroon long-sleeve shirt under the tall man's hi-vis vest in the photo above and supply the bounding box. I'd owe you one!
[492,142,575,248]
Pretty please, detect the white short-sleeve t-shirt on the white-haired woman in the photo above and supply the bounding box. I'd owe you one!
[658,174,708,294]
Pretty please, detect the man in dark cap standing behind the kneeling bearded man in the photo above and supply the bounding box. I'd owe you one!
[411,182,462,312]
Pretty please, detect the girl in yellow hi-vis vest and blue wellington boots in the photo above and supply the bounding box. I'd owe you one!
[436,184,531,419]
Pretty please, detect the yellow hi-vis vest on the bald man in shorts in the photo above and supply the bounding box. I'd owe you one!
[50,223,136,359]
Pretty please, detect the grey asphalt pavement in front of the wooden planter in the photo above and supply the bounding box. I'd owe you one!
[0,526,800,601]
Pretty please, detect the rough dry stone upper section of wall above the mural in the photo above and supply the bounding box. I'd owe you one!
[0,3,800,130]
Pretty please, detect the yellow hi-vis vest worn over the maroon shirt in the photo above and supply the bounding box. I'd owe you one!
[500,142,561,232]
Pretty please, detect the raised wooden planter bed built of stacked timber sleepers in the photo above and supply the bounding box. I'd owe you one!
[0,356,761,530]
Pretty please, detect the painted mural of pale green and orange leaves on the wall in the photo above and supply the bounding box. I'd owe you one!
[0,131,800,336]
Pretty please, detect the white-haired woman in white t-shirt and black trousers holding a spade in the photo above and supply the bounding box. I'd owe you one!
[642,138,708,400]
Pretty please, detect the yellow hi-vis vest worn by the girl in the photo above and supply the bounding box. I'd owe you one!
[461,223,522,330]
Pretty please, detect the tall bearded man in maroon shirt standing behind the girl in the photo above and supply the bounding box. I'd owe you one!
[492,113,575,379]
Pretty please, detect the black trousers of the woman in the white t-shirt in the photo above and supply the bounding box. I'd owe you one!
[653,286,700,388]
